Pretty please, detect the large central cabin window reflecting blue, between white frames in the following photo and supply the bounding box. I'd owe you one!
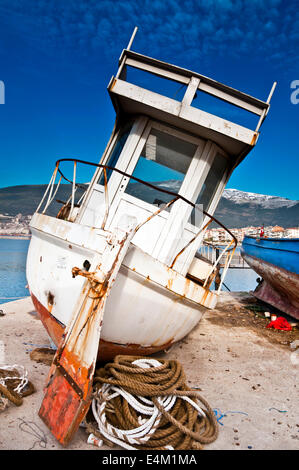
[126,128,197,206]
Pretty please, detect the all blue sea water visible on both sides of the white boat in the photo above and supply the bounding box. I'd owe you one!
[0,238,258,304]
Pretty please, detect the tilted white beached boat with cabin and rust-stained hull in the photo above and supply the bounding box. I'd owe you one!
[27,28,275,360]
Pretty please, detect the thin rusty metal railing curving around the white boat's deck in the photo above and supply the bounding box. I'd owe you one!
[36,158,237,292]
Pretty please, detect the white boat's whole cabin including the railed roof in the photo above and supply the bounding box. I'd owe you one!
[72,45,269,275]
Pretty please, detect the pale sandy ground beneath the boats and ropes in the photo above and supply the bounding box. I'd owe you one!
[0,293,299,451]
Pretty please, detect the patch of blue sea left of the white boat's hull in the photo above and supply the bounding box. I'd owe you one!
[0,238,29,304]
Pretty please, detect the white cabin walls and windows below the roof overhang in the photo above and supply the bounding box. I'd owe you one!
[80,116,229,274]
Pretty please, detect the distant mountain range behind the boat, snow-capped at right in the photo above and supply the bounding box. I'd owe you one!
[0,180,299,228]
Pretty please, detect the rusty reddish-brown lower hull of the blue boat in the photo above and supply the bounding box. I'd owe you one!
[243,255,299,319]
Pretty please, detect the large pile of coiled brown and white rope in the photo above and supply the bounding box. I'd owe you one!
[86,356,218,450]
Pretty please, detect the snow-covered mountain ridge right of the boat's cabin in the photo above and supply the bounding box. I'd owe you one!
[223,189,299,209]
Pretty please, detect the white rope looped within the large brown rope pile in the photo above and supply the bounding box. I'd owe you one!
[91,358,206,450]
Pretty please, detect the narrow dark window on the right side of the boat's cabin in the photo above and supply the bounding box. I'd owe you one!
[191,153,228,225]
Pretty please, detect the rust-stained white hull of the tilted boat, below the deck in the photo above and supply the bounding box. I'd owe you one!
[27,214,217,360]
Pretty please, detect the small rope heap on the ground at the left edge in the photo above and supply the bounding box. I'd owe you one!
[0,364,35,411]
